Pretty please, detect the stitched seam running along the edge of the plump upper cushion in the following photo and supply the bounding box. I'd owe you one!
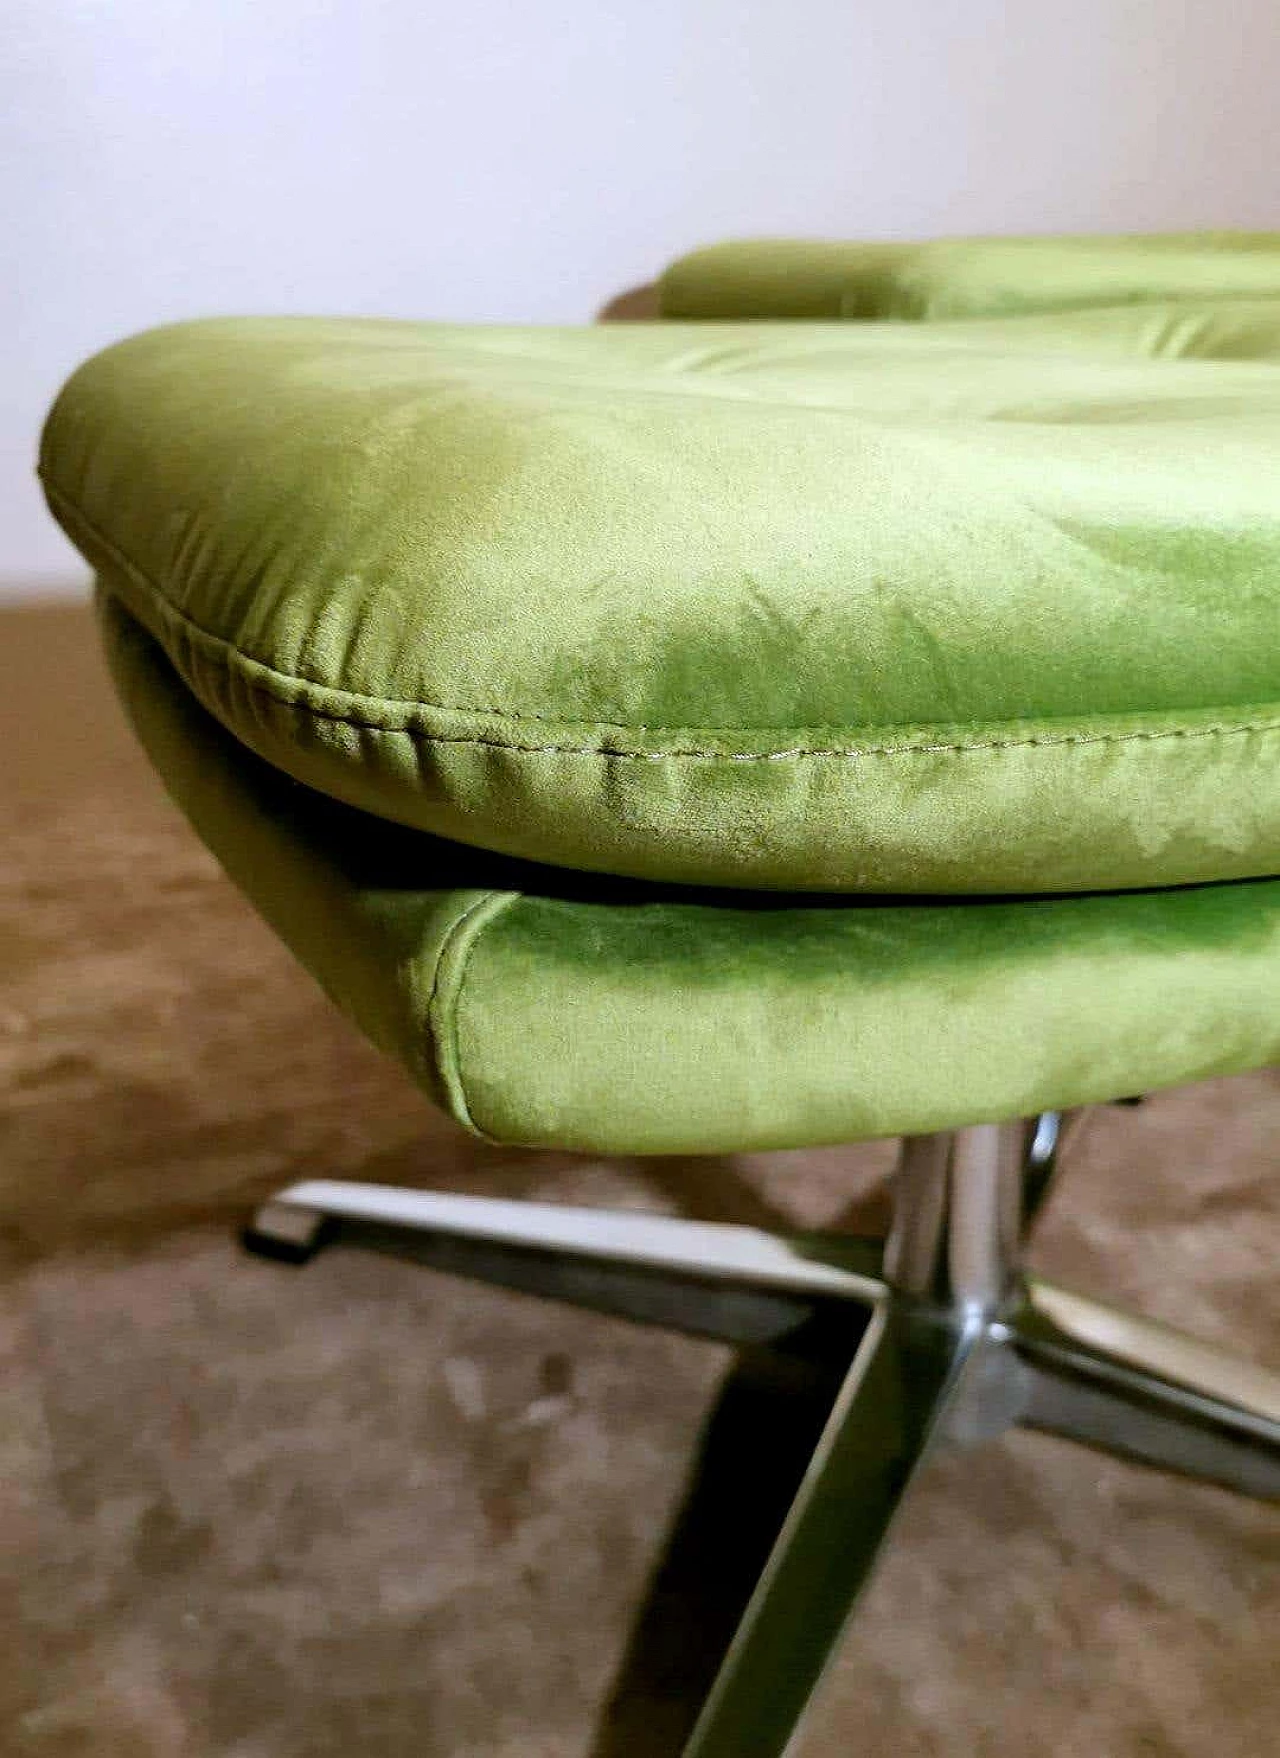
[42,478,1280,763]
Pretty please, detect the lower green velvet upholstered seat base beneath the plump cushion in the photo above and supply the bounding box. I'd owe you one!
[104,594,1280,1153]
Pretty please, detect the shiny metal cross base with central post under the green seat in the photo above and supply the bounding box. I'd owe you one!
[246,1113,1280,1758]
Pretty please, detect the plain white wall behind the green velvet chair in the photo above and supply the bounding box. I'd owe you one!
[0,0,1280,592]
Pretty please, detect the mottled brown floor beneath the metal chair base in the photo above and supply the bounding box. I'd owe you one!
[0,608,1280,1758]
